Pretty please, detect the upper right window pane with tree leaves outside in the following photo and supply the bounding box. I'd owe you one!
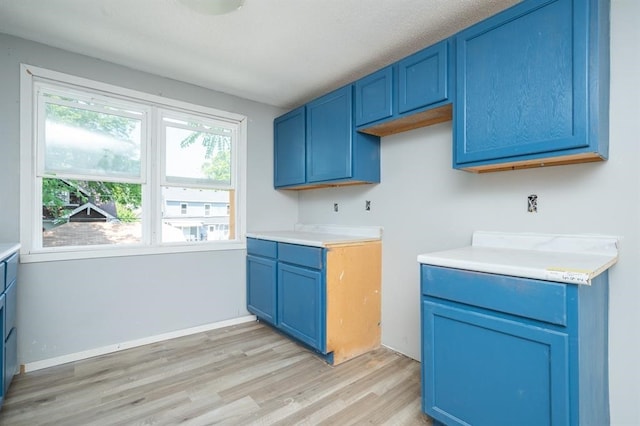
[163,118,232,186]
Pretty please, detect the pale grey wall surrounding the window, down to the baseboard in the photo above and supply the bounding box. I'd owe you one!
[0,34,298,364]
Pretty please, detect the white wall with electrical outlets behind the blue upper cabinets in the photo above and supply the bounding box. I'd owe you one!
[300,0,640,425]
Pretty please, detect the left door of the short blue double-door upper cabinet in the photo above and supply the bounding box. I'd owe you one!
[354,66,393,126]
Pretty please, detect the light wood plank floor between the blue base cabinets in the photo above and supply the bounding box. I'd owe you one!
[0,322,431,426]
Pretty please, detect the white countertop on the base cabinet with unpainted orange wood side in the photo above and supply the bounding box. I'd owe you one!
[247,224,382,247]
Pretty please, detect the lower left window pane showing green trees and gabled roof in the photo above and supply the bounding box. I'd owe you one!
[42,178,142,247]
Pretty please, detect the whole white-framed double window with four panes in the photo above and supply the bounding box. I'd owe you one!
[21,65,246,261]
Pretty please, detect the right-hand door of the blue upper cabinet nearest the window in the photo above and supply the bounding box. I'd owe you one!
[307,86,354,182]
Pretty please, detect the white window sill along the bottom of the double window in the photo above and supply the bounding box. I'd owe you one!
[20,239,247,263]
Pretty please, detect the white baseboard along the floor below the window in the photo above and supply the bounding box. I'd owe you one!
[20,315,256,373]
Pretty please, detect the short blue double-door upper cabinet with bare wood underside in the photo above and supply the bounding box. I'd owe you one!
[355,39,454,136]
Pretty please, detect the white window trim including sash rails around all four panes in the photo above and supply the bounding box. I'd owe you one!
[20,64,247,262]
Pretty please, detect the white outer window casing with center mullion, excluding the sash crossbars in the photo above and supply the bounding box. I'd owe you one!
[20,64,248,262]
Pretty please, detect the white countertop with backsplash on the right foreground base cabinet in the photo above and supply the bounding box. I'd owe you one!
[418,232,618,285]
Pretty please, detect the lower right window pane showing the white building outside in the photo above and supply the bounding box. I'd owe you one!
[162,186,234,243]
